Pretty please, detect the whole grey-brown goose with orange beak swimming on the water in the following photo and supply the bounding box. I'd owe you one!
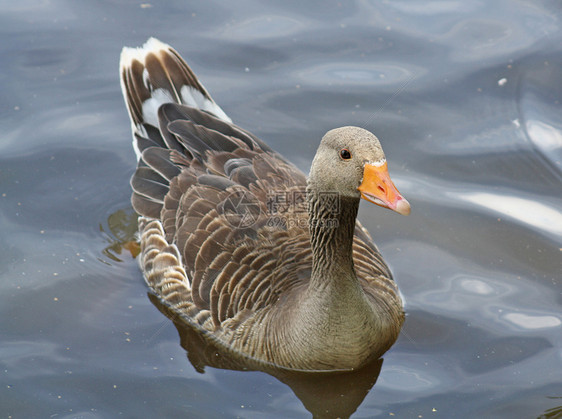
[120,38,410,371]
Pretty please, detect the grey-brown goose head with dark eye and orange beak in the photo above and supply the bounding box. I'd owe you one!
[308,127,410,215]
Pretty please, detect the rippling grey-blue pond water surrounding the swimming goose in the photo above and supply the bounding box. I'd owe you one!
[0,0,562,418]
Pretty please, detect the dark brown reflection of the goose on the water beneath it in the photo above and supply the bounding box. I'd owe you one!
[148,294,383,418]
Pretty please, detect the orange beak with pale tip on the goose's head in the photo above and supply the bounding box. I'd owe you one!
[357,162,410,215]
